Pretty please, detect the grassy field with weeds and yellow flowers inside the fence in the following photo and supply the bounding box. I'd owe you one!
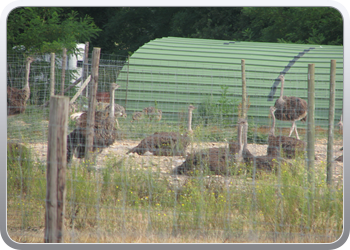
[7,107,343,243]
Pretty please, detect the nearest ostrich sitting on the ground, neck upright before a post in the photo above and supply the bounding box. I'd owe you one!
[174,119,244,175]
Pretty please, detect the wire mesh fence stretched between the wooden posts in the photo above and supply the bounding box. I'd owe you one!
[7,48,343,243]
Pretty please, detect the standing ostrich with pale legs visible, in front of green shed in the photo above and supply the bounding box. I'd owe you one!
[275,75,307,140]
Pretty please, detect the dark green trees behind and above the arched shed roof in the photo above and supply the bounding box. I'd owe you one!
[67,7,343,55]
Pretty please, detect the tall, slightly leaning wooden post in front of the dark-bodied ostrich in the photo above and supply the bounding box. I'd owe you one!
[85,48,101,159]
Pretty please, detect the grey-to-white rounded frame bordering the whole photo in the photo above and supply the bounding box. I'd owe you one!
[0,0,350,249]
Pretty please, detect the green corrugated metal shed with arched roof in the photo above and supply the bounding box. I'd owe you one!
[117,37,343,127]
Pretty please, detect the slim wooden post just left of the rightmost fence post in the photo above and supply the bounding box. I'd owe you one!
[307,64,315,190]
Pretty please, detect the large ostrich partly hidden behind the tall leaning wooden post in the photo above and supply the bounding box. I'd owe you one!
[67,83,119,163]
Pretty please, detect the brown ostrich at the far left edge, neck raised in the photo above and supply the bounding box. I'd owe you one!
[7,57,35,116]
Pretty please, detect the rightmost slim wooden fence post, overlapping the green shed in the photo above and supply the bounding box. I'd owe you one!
[327,60,336,185]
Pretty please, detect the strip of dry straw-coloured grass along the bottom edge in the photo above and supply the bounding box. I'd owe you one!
[8,229,338,243]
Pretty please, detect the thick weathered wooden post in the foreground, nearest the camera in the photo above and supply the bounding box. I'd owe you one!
[44,96,69,243]
